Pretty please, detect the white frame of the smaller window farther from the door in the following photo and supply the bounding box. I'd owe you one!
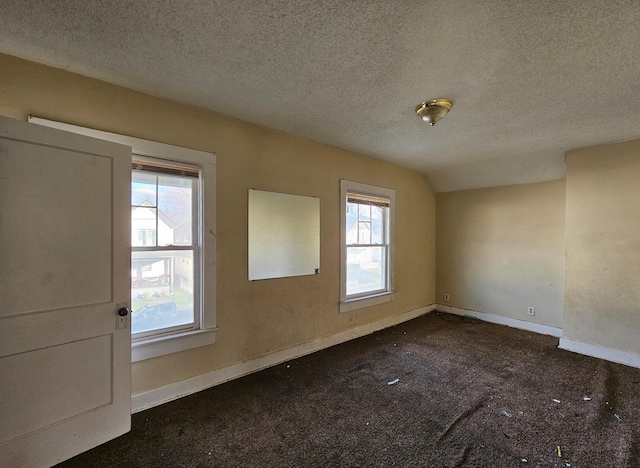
[339,179,395,312]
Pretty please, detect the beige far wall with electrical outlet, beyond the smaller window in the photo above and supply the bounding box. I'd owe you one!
[436,180,565,327]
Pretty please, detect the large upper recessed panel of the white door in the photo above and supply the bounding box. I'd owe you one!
[0,141,112,315]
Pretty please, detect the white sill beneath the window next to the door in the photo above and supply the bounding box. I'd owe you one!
[131,328,218,362]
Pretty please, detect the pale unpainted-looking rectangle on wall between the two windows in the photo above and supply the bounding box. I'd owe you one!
[249,189,320,281]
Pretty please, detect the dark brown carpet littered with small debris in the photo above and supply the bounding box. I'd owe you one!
[58,312,640,468]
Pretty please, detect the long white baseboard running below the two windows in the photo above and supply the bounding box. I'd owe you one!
[131,304,436,413]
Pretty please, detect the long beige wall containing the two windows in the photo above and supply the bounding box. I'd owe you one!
[0,55,435,393]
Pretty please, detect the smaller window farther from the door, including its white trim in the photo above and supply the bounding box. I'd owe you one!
[340,180,395,312]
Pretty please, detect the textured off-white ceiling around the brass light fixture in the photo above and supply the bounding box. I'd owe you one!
[0,0,640,191]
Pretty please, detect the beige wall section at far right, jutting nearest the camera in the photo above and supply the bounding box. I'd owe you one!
[564,140,640,354]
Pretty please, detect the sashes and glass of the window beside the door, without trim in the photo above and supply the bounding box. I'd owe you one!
[131,155,200,339]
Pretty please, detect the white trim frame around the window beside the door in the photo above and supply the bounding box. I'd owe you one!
[28,116,218,362]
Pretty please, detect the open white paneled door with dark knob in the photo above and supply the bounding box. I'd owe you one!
[0,117,131,467]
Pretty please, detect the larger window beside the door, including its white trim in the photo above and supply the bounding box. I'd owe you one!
[29,117,217,362]
